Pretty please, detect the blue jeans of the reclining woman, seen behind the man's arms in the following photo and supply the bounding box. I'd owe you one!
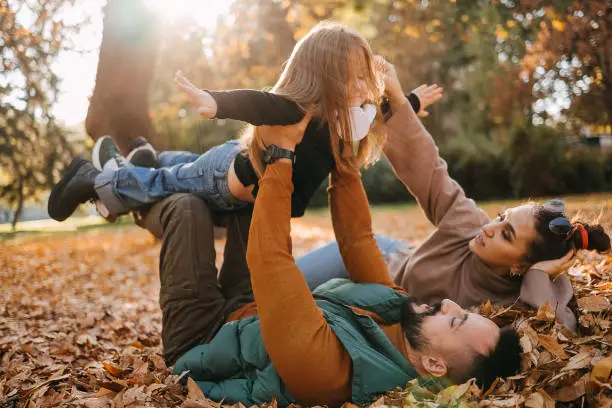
[296,235,406,290]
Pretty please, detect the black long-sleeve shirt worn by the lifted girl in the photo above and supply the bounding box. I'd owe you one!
[207,89,420,217]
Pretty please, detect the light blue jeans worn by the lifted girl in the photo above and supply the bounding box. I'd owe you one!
[96,140,248,215]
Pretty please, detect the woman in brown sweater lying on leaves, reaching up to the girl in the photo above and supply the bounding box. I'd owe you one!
[298,62,610,329]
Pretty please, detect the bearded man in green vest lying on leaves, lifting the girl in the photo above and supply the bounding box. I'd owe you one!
[130,109,520,406]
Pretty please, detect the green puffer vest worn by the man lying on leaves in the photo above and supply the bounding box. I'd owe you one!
[174,279,438,407]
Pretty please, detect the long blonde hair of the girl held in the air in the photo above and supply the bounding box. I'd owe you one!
[242,22,386,177]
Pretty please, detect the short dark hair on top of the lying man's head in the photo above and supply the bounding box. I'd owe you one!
[465,326,523,391]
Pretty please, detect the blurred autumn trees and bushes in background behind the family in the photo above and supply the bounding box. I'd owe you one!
[0,0,612,222]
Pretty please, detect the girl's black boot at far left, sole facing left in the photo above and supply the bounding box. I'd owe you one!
[47,157,100,221]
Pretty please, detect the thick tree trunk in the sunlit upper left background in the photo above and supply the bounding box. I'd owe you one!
[85,0,162,154]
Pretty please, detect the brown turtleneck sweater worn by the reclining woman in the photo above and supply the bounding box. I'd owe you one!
[385,104,576,329]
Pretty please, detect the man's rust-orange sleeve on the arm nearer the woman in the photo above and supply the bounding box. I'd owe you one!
[327,166,401,289]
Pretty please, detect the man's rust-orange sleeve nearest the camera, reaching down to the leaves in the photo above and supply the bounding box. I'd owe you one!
[247,162,351,405]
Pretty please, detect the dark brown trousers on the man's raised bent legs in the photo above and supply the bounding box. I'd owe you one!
[137,194,253,365]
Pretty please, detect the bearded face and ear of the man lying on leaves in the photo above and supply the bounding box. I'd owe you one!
[404,299,499,375]
